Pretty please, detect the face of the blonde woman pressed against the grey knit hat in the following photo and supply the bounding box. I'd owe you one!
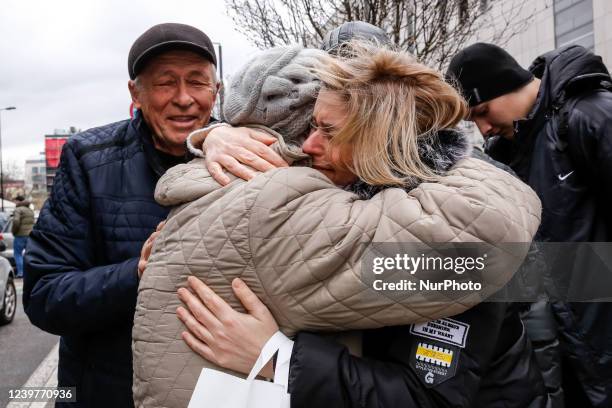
[302,90,357,186]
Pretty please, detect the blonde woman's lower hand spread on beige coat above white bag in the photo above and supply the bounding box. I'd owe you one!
[176,276,278,378]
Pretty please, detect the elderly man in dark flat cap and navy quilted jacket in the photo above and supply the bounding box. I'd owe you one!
[23,24,219,407]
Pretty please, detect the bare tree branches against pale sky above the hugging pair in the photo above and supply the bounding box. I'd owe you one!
[225,0,536,69]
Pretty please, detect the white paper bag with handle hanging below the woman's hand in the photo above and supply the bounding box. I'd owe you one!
[188,331,293,408]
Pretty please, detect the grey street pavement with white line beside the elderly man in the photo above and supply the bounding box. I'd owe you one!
[0,279,59,408]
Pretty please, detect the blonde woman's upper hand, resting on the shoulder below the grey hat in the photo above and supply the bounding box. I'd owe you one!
[202,126,289,186]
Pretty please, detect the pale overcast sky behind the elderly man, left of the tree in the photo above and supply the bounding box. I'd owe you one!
[0,0,257,174]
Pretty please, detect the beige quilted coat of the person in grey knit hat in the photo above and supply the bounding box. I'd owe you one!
[133,128,540,407]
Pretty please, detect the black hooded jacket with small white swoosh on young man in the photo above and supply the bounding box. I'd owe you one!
[487,46,612,407]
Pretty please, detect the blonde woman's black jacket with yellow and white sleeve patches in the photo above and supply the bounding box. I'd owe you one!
[289,303,547,408]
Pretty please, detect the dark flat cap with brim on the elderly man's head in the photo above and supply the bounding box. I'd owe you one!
[128,23,217,79]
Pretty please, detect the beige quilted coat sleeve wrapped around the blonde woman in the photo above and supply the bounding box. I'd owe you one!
[249,163,540,333]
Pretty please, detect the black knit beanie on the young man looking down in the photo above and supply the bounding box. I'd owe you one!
[446,43,533,107]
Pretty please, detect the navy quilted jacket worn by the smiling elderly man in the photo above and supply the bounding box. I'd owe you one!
[23,115,185,407]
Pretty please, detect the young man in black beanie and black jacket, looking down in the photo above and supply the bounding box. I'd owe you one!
[447,43,612,407]
